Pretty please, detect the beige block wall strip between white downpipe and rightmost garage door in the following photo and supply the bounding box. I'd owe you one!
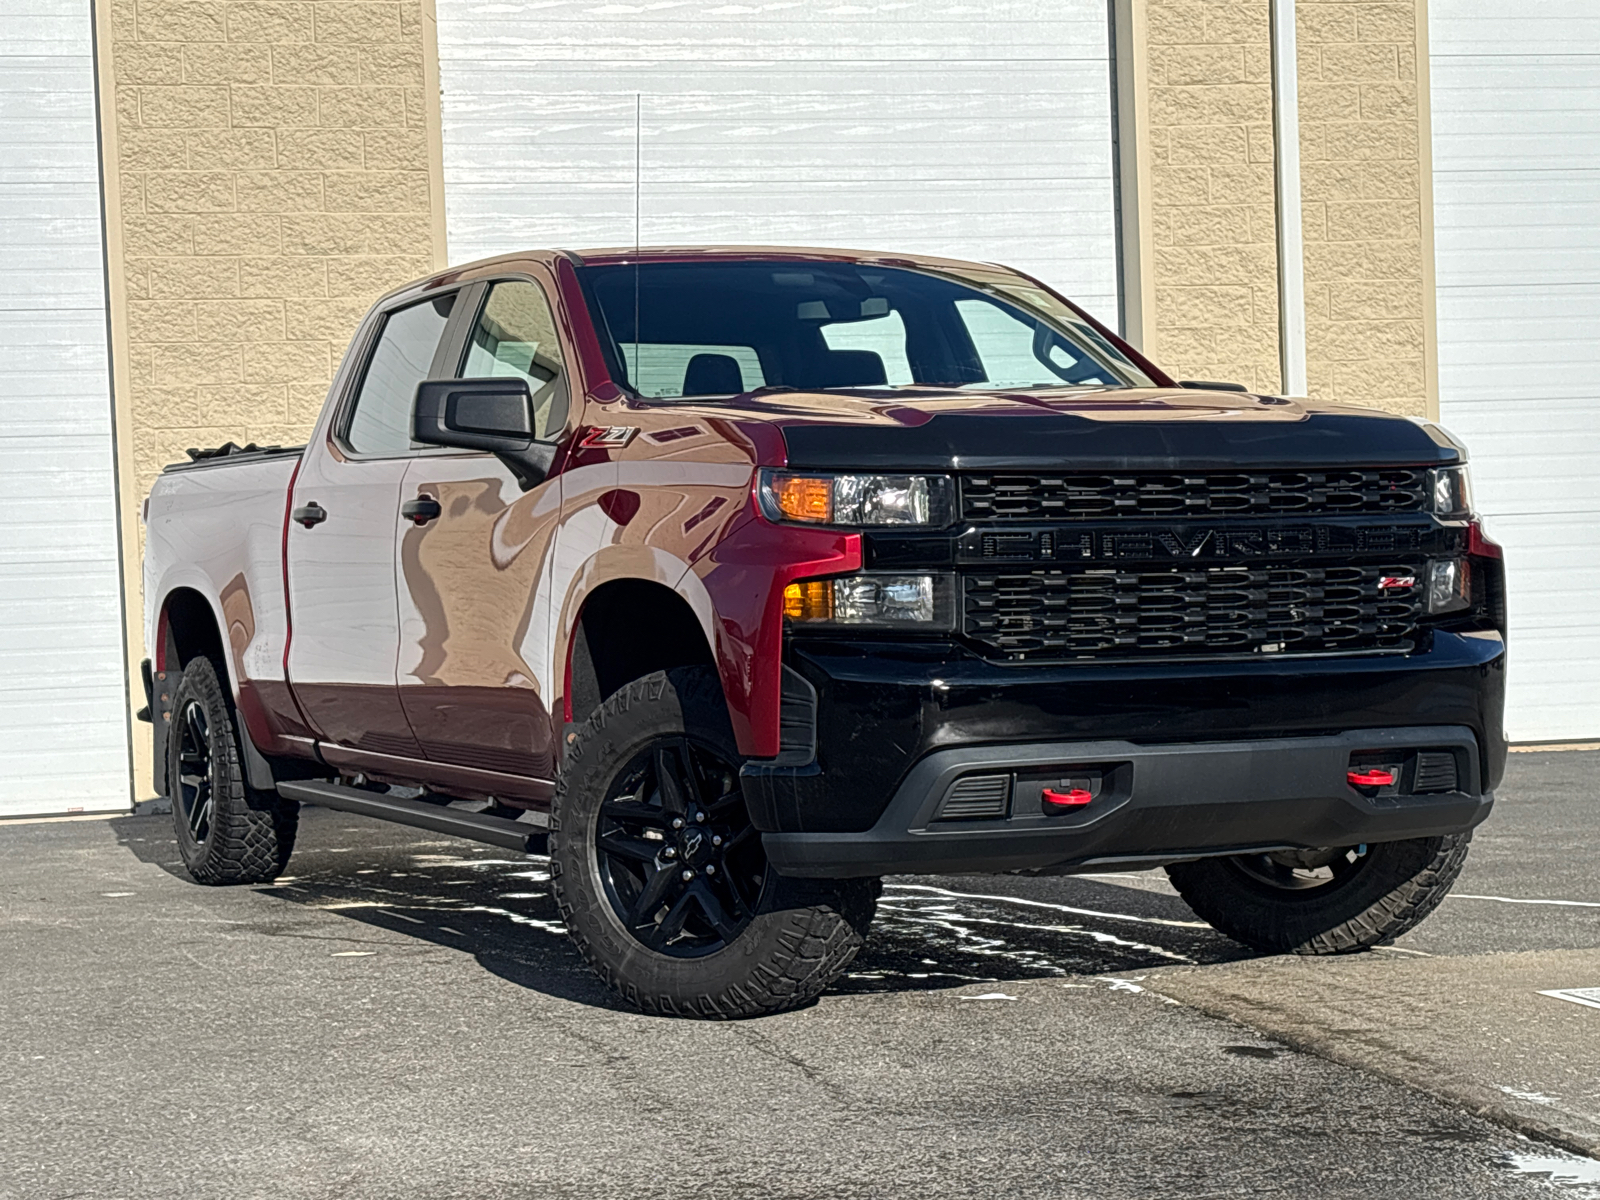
[1294,0,1432,416]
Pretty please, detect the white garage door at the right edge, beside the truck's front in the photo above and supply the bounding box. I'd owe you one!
[1429,0,1600,741]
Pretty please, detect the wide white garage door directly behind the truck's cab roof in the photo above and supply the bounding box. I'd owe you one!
[438,0,1117,325]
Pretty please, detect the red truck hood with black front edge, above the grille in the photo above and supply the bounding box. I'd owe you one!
[718,387,1466,470]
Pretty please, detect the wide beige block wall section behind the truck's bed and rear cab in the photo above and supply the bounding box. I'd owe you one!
[101,0,445,502]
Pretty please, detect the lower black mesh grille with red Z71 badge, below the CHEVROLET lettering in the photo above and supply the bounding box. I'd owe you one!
[962,563,1422,661]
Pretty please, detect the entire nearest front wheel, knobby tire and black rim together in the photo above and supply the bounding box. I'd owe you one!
[550,667,877,1018]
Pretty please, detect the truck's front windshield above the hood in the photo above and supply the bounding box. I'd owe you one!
[579,261,1150,398]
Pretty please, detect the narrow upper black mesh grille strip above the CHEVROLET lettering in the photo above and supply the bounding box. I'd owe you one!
[962,467,1427,522]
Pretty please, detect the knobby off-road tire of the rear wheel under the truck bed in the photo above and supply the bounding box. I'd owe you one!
[166,658,299,885]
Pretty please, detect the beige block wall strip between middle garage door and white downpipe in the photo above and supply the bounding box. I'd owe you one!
[1146,0,1280,390]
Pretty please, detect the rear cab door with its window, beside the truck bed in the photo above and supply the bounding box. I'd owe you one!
[285,291,458,758]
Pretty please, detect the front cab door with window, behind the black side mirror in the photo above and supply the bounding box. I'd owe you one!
[397,278,570,779]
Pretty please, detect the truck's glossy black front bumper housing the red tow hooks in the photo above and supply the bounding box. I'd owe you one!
[742,632,1506,875]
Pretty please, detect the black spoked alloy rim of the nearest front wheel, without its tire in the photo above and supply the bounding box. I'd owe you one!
[595,738,766,958]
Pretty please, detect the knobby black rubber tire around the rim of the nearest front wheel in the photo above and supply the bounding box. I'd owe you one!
[550,667,882,1019]
